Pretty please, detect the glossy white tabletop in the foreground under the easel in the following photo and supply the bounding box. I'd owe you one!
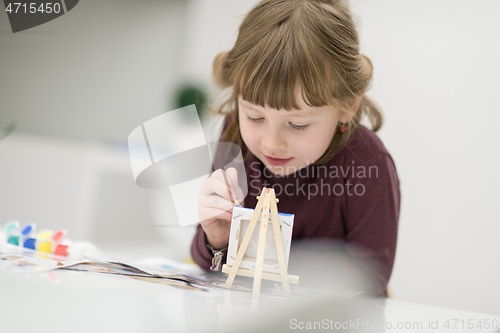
[0,260,500,333]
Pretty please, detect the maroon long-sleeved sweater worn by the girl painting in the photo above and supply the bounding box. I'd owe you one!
[191,122,400,294]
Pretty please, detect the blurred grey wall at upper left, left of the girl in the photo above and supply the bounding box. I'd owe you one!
[0,0,186,142]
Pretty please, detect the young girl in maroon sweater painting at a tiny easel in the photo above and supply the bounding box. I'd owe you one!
[192,0,400,294]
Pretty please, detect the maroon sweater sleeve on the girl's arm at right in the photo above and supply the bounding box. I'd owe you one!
[344,153,400,295]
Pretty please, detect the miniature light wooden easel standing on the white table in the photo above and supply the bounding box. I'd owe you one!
[222,187,299,297]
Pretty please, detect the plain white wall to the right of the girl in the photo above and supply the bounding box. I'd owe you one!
[353,1,500,314]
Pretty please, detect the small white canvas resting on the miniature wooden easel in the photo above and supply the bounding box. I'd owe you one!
[227,207,294,273]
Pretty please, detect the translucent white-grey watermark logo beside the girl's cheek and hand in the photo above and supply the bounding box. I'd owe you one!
[128,105,248,226]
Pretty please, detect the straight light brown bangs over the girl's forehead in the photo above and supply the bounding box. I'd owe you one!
[232,22,337,111]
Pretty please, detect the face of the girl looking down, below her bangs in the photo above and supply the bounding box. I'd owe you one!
[238,92,346,175]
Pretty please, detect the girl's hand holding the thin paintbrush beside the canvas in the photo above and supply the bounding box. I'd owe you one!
[198,168,243,249]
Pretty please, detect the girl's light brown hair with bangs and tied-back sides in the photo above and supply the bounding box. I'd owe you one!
[210,0,383,164]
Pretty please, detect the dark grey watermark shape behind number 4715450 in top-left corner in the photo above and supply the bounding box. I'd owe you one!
[3,0,79,33]
